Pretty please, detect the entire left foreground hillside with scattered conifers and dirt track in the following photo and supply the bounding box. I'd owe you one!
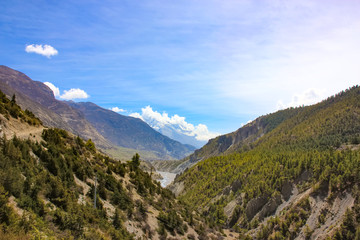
[0,89,234,240]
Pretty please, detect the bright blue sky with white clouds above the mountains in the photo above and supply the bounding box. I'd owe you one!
[0,0,360,141]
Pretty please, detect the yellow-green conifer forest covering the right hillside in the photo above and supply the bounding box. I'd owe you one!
[176,86,360,239]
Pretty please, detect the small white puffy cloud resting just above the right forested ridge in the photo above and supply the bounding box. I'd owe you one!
[277,89,324,110]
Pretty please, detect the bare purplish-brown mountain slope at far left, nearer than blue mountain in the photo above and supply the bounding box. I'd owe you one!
[0,66,113,148]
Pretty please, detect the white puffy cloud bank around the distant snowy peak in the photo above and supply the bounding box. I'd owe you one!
[130,106,220,141]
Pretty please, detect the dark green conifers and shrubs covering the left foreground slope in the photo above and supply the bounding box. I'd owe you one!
[0,129,205,239]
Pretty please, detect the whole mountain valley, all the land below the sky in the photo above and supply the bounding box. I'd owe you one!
[0,67,360,240]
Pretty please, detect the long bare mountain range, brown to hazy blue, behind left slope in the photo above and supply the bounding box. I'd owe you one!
[0,66,195,160]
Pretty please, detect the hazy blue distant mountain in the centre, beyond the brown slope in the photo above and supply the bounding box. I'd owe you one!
[66,101,195,159]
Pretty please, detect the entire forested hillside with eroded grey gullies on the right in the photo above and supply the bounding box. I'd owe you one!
[170,86,360,239]
